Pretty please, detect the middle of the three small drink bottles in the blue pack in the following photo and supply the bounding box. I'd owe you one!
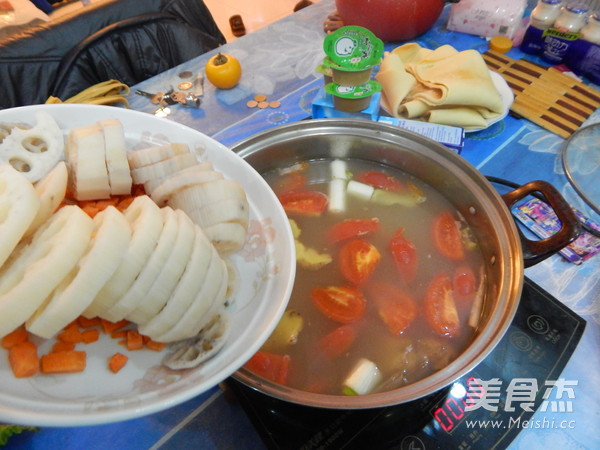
[542,3,588,64]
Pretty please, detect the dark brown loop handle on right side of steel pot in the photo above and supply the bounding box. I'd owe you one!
[502,180,581,267]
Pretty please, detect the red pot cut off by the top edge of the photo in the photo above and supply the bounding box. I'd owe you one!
[335,0,445,41]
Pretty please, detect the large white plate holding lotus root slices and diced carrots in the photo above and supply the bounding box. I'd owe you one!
[0,104,295,426]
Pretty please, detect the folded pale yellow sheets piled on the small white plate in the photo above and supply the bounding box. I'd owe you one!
[376,43,504,129]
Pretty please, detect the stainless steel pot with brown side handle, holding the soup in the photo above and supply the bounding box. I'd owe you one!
[232,119,580,409]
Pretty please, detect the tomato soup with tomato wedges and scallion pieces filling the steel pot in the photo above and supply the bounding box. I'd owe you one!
[245,160,485,395]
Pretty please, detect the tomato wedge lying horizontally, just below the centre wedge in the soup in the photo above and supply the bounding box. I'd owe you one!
[311,286,367,323]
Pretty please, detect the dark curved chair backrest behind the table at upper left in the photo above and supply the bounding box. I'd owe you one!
[52,13,222,100]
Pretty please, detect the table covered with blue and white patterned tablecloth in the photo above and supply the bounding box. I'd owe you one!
[9,0,600,449]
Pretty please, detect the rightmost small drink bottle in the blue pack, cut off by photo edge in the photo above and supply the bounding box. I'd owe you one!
[564,12,600,84]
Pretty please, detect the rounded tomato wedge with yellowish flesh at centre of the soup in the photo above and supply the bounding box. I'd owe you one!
[339,239,381,286]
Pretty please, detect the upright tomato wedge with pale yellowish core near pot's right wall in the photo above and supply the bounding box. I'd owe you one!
[423,272,460,337]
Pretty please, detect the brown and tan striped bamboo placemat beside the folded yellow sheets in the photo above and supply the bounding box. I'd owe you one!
[483,50,600,138]
